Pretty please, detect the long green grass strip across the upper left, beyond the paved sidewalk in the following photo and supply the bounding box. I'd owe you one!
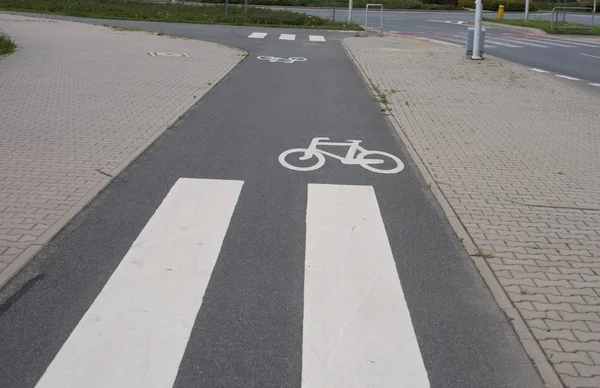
[0,0,361,30]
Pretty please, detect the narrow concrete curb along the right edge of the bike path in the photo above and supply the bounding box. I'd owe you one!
[342,38,564,388]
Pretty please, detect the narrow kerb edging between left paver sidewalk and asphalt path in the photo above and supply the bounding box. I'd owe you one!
[0,42,247,290]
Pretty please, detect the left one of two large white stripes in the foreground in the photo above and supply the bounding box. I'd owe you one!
[36,179,243,388]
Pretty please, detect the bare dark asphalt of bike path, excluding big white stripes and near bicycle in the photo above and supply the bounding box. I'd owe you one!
[0,12,542,388]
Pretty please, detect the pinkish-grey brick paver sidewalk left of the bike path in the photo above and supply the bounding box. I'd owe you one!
[0,14,244,286]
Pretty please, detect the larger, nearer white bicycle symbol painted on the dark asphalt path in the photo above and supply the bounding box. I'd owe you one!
[279,137,404,174]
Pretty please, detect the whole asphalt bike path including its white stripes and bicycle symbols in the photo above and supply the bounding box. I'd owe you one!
[0,16,541,388]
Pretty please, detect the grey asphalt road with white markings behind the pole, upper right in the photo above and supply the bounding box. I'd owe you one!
[289,8,600,84]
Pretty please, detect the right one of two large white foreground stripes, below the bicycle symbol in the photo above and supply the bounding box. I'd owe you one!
[302,184,429,388]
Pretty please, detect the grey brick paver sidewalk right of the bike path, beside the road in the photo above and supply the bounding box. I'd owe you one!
[345,38,600,387]
